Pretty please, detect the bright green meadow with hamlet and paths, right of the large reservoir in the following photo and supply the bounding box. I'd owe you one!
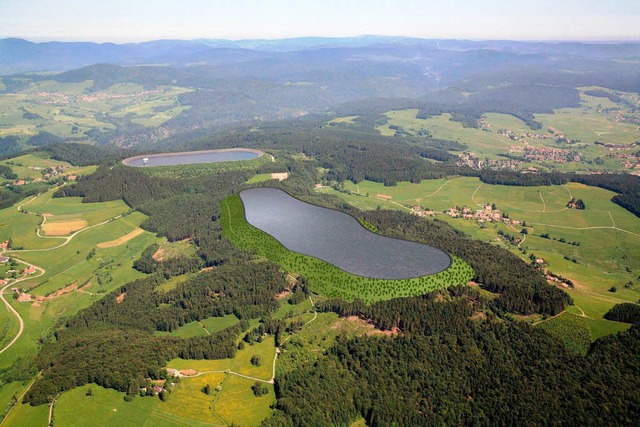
[317,177,640,337]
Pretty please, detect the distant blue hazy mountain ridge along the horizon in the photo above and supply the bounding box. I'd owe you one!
[0,36,640,75]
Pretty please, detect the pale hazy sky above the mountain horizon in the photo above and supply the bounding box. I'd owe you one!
[0,0,640,42]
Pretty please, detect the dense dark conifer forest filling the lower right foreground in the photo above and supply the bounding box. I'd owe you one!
[272,287,640,426]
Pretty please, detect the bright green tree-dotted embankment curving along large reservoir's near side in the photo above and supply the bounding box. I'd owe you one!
[221,195,473,302]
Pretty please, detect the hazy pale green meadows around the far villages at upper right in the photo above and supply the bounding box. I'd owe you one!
[376,88,640,171]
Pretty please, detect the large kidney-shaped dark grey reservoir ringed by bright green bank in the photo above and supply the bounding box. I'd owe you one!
[240,188,451,279]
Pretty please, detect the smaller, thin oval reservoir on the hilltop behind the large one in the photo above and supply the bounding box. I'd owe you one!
[122,148,263,167]
